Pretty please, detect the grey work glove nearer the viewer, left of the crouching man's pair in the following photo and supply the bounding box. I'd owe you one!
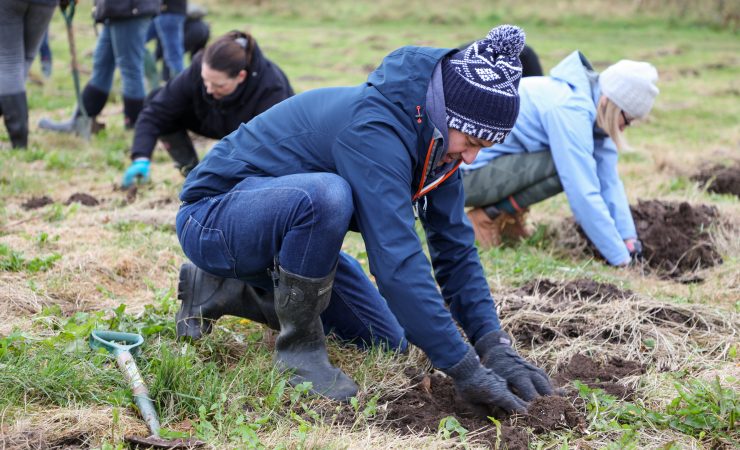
[443,348,527,416]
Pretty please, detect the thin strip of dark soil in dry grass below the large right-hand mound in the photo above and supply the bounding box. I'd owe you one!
[517,278,635,303]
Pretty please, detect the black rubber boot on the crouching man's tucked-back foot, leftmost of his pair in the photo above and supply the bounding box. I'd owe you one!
[175,263,280,340]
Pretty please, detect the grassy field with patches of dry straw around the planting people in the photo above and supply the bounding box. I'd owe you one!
[0,0,740,449]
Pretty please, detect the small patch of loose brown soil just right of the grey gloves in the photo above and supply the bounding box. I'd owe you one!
[554,353,645,398]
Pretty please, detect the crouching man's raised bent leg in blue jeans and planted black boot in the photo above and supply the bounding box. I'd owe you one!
[176,173,357,400]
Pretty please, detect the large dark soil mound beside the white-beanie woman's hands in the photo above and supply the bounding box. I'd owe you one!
[631,200,722,278]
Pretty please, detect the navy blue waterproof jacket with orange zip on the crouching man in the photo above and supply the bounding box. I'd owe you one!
[180,47,500,369]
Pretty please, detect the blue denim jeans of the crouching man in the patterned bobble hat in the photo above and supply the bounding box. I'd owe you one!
[176,173,408,351]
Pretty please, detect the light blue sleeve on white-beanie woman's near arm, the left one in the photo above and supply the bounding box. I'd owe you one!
[543,106,629,265]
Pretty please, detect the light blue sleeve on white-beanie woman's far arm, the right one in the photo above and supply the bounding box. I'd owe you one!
[594,138,637,240]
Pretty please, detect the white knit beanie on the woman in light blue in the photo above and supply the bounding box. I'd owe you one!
[599,59,659,119]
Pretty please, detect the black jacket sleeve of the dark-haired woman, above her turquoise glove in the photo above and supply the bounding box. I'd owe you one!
[131,60,200,159]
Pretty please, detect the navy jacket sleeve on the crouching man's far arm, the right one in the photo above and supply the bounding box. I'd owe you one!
[420,172,501,343]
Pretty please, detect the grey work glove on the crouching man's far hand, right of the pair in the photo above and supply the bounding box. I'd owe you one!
[475,330,553,402]
